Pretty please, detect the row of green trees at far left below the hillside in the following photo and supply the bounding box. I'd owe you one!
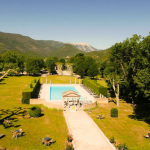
[0,51,45,74]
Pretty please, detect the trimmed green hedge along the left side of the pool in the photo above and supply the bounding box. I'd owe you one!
[22,79,40,104]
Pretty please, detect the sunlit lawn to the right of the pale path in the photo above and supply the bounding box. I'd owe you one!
[89,101,150,150]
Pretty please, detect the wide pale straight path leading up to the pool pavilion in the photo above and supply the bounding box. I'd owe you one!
[64,111,115,150]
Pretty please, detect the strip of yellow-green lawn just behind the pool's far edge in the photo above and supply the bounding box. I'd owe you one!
[41,75,82,84]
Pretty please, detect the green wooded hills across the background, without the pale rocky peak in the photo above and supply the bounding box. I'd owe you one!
[0,32,110,61]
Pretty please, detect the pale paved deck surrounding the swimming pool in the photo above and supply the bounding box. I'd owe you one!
[40,84,94,105]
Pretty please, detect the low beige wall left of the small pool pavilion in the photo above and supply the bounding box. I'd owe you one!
[30,99,64,109]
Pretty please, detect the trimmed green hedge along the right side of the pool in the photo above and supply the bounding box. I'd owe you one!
[82,78,108,97]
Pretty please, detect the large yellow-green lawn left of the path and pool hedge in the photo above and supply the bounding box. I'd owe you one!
[0,76,68,150]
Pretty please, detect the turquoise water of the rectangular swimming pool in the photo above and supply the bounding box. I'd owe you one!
[50,86,84,100]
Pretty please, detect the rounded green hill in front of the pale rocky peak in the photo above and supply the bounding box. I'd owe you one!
[51,44,83,58]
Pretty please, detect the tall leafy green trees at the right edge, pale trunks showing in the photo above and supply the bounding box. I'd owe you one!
[100,34,150,103]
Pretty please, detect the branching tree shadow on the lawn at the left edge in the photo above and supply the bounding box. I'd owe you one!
[0,107,27,128]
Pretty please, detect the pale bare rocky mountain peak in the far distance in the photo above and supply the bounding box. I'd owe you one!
[69,43,98,52]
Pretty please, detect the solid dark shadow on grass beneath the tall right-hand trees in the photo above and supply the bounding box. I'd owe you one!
[128,103,150,124]
